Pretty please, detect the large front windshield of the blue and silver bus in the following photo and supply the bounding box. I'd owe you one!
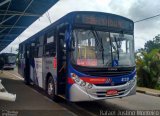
[71,29,134,67]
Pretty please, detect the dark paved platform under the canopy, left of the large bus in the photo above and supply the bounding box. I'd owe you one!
[0,71,76,116]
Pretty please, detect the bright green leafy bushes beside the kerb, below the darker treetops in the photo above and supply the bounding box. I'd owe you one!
[136,49,160,88]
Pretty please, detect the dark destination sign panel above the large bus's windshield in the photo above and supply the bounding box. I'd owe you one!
[75,13,133,30]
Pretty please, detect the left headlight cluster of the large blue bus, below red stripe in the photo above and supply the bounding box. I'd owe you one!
[71,73,93,89]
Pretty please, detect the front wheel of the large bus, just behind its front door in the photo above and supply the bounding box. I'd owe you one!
[46,76,58,102]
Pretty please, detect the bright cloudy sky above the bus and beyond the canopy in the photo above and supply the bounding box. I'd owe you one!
[1,0,160,53]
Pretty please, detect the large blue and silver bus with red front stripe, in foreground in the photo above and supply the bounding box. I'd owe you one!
[18,11,136,102]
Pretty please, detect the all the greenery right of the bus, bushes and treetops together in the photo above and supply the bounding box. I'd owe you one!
[136,35,160,89]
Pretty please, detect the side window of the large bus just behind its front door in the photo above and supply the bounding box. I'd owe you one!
[44,31,56,56]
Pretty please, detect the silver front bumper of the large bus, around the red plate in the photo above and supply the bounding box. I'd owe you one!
[70,78,136,102]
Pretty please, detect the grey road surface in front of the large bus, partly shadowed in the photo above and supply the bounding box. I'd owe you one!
[73,93,160,116]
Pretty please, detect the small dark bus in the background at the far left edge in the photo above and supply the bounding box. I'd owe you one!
[0,53,17,70]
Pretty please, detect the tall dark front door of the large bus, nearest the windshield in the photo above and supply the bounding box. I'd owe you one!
[57,25,67,95]
